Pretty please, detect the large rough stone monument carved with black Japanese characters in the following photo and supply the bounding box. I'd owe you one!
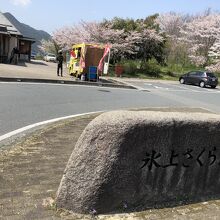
[56,111,220,213]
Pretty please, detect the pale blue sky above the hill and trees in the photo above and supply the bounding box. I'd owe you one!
[0,0,220,34]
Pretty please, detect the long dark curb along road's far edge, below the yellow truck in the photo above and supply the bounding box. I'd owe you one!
[0,77,136,89]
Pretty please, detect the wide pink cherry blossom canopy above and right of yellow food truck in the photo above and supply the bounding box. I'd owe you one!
[53,21,163,62]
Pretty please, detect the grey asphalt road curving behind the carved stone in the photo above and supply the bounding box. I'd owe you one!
[0,81,220,135]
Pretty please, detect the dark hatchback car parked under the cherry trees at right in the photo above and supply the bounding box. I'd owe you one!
[179,71,218,88]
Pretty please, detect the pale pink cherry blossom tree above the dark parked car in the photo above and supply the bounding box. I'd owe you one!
[156,10,220,66]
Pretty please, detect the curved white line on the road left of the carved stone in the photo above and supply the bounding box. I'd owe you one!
[0,111,104,142]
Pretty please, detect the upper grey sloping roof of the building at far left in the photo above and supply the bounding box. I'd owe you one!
[0,12,22,36]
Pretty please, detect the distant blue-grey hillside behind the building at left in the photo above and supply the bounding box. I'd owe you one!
[3,12,51,52]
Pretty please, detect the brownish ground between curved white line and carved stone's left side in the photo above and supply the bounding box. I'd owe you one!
[0,115,96,220]
